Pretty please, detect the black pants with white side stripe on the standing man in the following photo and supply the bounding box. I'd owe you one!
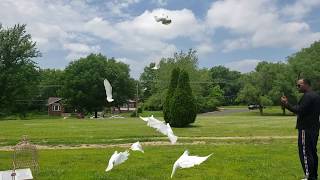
[298,129,319,180]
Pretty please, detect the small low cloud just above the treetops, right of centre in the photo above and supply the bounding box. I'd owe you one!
[224,59,261,73]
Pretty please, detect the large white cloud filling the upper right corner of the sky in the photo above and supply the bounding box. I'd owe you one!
[206,0,320,52]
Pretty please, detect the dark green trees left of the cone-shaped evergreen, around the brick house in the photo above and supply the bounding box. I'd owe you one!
[0,25,137,117]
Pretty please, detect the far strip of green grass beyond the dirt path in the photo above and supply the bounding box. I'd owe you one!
[0,114,295,146]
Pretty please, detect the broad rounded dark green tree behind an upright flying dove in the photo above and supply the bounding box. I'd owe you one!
[62,54,135,117]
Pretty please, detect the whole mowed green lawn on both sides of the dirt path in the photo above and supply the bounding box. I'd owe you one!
[0,109,303,180]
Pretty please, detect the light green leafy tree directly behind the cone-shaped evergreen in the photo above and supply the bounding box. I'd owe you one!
[140,49,212,110]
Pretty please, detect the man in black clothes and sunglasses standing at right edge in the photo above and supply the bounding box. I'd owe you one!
[281,79,320,180]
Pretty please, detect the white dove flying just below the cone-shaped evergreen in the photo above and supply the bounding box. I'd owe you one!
[140,115,178,144]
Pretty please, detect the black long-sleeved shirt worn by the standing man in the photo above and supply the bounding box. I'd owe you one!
[285,91,320,130]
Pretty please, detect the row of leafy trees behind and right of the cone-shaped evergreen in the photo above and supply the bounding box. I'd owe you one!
[140,41,320,114]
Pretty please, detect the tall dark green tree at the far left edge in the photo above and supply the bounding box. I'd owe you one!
[0,24,40,116]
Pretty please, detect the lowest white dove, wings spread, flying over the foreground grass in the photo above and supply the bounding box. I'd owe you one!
[171,150,212,178]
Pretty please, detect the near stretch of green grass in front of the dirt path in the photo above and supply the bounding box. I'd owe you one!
[0,141,302,180]
